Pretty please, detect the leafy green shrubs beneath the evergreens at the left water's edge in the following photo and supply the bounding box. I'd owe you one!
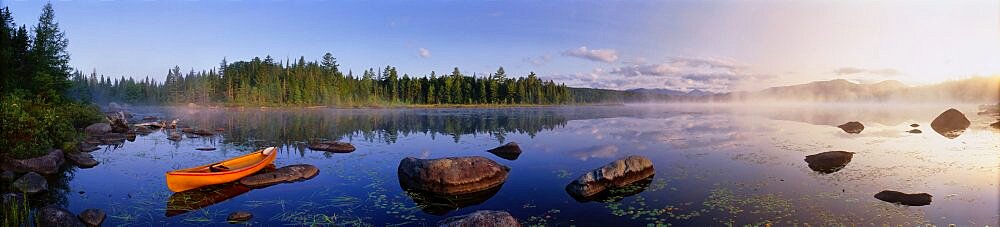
[0,95,94,159]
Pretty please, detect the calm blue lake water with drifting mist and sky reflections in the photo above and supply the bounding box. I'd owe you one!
[21,105,1000,226]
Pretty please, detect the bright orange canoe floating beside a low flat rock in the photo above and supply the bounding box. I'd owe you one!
[167,147,277,192]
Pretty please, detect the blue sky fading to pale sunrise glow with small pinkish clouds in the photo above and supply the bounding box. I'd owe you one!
[2,1,1000,91]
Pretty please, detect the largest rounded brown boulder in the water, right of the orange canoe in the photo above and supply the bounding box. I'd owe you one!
[397,156,510,195]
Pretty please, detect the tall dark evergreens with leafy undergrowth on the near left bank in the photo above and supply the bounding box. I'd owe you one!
[0,3,101,160]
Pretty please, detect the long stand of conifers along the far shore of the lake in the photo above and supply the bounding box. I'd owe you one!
[68,53,588,106]
